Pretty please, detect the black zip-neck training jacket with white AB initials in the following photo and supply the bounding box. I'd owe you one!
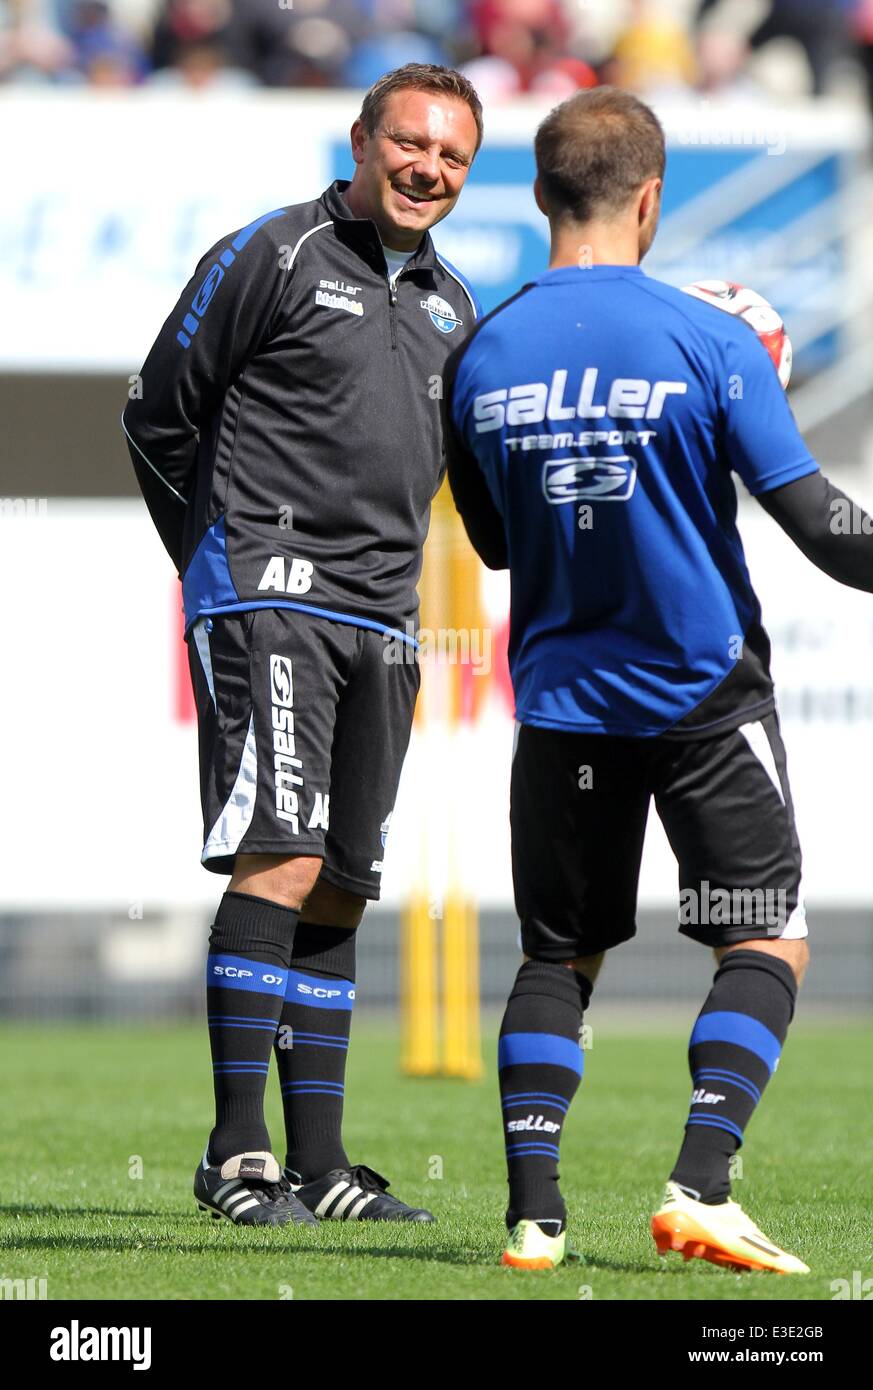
[122,181,480,631]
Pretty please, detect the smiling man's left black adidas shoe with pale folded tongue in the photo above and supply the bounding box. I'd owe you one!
[195,1152,318,1226]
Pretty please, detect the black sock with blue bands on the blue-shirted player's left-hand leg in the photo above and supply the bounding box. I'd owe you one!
[498,960,592,1236]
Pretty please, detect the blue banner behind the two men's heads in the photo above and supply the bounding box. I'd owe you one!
[332,142,845,379]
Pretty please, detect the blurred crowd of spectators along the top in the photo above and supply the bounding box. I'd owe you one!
[0,0,873,104]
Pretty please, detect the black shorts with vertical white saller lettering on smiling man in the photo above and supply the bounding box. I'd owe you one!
[188,609,420,899]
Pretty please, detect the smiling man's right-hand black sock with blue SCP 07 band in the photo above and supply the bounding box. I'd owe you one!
[275,922,357,1183]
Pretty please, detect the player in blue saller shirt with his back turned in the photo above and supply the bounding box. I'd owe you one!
[443,78,873,1273]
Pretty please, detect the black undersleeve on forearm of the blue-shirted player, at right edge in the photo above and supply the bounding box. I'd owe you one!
[758,473,873,594]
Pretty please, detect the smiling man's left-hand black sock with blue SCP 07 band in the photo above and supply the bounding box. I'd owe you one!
[206,892,297,1163]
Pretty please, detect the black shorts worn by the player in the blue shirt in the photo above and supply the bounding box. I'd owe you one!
[510,714,806,960]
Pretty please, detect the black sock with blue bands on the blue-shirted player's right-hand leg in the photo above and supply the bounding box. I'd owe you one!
[670,951,797,1205]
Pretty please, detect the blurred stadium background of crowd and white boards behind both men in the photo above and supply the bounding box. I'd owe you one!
[0,0,873,1020]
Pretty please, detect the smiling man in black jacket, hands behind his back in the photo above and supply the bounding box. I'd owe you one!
[122,64,482,1225]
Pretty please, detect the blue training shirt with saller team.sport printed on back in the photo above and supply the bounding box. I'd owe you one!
[446,265,817,737]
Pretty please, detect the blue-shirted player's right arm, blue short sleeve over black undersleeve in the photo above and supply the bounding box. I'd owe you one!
[721,332,873,592]
